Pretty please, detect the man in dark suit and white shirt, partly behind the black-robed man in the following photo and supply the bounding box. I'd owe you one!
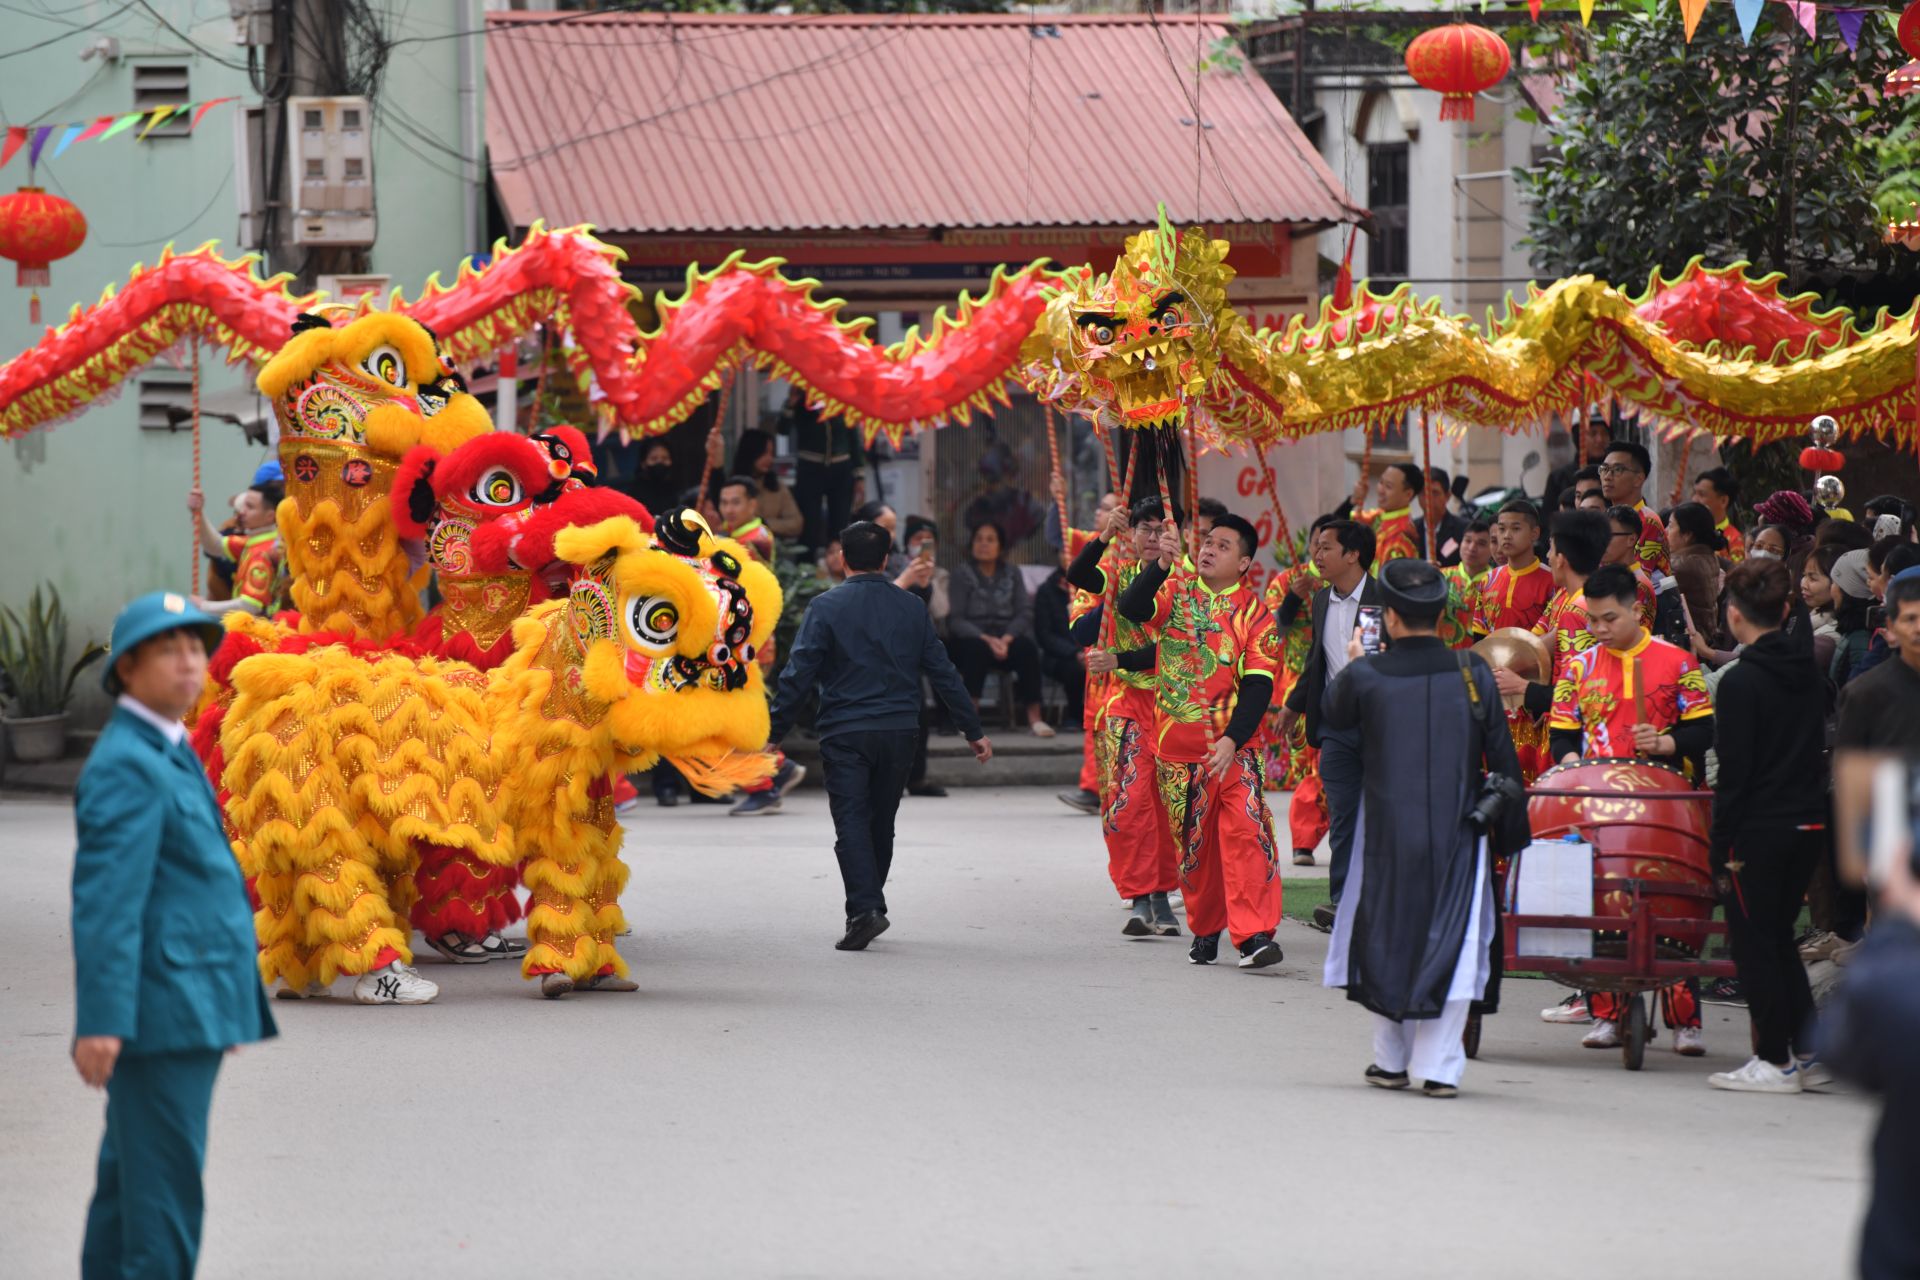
[1279,520,1380,929]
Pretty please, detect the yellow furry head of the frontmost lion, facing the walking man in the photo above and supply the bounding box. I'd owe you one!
[555,510,780,756]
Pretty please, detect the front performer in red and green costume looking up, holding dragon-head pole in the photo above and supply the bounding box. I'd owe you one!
[1119,514,1281,969]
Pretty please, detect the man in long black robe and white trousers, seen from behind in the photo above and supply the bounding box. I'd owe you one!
[1323,560,1526,1098]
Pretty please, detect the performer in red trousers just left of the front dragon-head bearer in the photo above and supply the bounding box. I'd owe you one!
[1068,497,1181,938]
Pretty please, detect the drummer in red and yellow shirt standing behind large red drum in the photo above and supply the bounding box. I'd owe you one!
[1548,564,1713,1057]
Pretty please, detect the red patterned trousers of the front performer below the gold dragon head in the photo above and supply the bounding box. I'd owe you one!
[1160,750,1281,946]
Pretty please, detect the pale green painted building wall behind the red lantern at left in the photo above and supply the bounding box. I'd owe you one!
[0,0,484,720]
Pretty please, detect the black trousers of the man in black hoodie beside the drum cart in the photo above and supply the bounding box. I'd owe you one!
[1724,827,1826,1067]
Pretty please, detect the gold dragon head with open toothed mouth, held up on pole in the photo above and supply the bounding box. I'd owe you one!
[1025,211,1238,430]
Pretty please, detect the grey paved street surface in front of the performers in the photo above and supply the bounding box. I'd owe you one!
[0,789,1870,1280]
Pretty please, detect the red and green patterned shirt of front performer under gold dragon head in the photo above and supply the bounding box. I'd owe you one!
[1146,572,1284,764]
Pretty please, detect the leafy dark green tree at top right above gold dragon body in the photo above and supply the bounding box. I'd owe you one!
[1519,4,1920,305]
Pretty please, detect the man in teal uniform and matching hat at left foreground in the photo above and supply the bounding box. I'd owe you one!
[73,591,275,1280]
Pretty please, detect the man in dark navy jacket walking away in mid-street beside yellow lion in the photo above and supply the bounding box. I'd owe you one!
[772,520,993,952]
